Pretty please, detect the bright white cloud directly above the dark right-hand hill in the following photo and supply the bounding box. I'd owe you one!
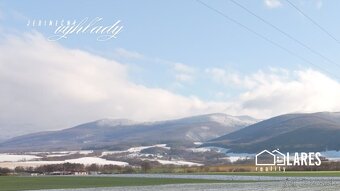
[207,69,340,118]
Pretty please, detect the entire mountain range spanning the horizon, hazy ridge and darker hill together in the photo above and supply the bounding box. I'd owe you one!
[0,112,340,153]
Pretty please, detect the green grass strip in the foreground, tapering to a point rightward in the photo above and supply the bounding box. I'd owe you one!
[0,176,253,191]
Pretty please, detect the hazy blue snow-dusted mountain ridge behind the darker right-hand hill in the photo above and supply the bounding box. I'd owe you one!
[0,114,256,151]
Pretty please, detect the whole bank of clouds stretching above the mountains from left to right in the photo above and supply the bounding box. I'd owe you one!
[0,33,340,138]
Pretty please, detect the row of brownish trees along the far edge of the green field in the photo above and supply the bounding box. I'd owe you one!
[0,160,340,176]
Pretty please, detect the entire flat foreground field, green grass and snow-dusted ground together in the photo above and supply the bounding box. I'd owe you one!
[0,173,340,191]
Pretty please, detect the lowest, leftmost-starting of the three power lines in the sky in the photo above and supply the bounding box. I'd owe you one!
[196,0,340,79]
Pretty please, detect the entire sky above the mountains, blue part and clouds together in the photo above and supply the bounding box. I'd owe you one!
[0,0,340,139]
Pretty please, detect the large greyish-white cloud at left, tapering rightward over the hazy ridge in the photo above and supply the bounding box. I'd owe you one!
[0,33,226,137]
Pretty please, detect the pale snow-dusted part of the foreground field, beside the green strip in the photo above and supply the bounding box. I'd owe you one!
[29,174,340,191]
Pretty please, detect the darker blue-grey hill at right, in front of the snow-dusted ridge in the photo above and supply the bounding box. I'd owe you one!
[205,112,340,153]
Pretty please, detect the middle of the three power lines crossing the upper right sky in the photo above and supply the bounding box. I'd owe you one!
[230,0,340,68]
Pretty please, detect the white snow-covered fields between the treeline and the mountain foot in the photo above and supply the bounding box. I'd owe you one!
[0,147,340,169]
